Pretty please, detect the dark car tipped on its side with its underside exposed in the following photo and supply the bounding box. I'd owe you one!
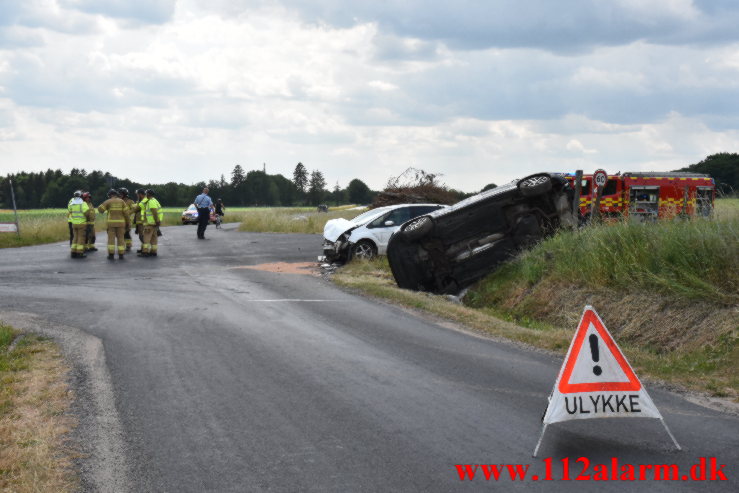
[387,173,577,294]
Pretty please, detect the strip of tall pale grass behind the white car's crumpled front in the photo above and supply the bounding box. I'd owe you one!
[239,205,366,234]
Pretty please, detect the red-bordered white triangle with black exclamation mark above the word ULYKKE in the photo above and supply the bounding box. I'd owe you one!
[558,307,641,394]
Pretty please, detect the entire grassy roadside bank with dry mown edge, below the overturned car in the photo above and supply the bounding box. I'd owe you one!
[334,200,739,400]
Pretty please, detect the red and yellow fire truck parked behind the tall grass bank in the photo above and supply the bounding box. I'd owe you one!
[567,172,716,219]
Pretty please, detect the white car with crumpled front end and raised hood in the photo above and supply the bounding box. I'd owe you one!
[323,204,447,262]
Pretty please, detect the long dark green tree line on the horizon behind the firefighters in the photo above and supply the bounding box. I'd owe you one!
[0,163,377,209]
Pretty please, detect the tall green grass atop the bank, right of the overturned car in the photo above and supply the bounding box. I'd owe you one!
[472,209,739,305]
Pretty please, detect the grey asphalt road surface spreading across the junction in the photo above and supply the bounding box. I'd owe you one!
[0,226,739,492]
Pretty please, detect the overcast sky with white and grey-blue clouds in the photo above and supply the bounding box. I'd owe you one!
[0,0,739,191]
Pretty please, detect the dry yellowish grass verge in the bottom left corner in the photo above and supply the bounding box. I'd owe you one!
[0,324,79,492]
